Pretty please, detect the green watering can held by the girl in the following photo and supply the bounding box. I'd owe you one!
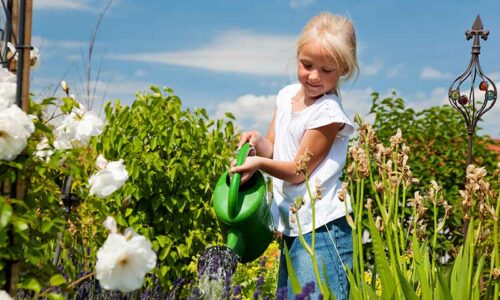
[214,143,273,263]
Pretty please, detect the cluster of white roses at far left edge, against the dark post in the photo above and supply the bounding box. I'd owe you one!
[0,68,35,161]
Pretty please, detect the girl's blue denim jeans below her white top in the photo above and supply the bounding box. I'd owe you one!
[277,217,353,300]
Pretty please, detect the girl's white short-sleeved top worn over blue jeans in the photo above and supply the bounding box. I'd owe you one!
[271,84,354,236]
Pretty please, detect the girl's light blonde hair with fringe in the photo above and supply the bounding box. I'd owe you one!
[297,12,359,82]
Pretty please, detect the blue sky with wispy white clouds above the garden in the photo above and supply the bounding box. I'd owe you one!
[31,0,500,138]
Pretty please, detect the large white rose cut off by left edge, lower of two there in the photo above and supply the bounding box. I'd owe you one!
[0,105,35,160]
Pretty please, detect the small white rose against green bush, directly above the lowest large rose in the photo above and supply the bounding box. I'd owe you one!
[89,155,128,198]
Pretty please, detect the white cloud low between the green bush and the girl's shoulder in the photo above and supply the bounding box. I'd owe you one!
[215,94,276,134]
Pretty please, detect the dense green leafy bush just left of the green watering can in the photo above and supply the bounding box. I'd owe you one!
[96,87,236,286]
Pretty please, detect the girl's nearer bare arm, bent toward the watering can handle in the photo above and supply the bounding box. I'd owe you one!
[231,123,342,184]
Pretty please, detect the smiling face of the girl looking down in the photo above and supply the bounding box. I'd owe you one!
[297,41,340,100]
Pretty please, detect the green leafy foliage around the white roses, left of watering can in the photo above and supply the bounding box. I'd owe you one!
[0,87,236,293]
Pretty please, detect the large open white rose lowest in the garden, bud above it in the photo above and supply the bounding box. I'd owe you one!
[95,217,156,293]
